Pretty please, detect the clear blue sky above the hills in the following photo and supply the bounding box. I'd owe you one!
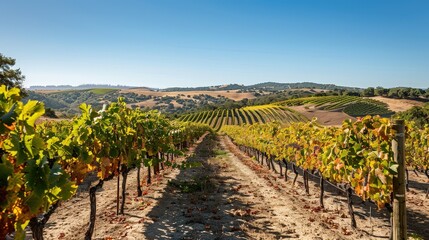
[0,0,429,88]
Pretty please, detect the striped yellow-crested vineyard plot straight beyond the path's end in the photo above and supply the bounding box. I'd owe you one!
[179,105,308,131]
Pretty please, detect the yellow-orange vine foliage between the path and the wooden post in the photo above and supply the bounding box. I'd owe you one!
[222,116,397,208]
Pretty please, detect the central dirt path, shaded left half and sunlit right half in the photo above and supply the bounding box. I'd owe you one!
[143,134,341,239]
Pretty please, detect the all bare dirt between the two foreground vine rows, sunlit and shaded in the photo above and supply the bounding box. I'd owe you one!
[45,135,428,239]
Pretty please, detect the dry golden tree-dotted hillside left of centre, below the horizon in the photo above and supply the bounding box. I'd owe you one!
[26,88,255,117]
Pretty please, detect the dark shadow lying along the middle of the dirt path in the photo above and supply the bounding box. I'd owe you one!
[144,135,290,239]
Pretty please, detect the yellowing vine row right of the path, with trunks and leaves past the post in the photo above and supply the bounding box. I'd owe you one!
[221,116,429,238]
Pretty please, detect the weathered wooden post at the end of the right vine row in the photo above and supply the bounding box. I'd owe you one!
[392,120,407,240]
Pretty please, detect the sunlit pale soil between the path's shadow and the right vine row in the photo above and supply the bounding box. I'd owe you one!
[222,137,388,239]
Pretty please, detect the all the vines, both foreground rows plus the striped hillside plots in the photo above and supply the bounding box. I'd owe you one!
[0,86,429,239]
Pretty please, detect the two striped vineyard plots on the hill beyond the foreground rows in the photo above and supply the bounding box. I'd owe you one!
[179,96,393,131]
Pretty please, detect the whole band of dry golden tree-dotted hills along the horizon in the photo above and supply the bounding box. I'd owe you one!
[27,82,429,121]
